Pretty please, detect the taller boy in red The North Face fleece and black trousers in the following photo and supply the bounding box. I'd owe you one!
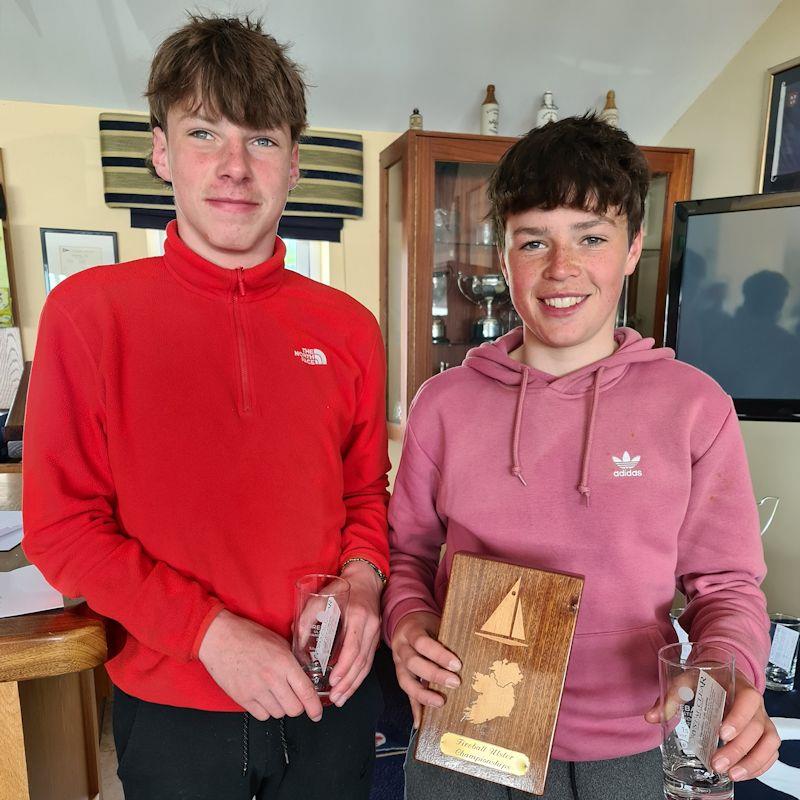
[23,17,388,800]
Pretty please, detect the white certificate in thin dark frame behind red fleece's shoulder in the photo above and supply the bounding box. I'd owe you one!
[40,228,119,293]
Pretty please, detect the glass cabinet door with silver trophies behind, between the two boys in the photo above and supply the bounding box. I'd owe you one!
[428,161,518,377]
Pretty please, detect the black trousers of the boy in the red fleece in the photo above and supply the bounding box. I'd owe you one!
[114,672,383,800]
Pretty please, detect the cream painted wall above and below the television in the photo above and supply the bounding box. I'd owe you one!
[661,0,800,614]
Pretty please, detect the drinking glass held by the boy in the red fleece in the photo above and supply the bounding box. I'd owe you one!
[292,574,350,706]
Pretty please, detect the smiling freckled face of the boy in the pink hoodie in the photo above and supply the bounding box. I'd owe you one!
[501,207,642,364]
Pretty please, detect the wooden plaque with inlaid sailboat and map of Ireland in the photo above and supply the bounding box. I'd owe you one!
[414,553,583,795]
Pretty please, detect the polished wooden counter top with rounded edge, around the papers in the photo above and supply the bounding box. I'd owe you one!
[0,473,107,681]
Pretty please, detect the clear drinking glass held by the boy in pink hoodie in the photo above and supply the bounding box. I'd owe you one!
[658,642,734,800]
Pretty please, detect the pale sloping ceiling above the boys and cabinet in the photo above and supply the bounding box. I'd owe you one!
[0,0,779,145]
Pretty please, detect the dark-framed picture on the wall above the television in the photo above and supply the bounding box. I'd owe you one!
[759,58,800,193]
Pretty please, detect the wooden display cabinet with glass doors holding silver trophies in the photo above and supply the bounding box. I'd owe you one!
[380,130,692,435]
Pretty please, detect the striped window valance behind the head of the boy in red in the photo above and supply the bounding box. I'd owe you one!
[95,114,364,219]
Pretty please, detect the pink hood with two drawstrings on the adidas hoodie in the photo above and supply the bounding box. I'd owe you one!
[464,328,675,505]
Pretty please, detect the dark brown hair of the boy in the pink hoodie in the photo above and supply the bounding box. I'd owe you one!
[489,112,650,246]
